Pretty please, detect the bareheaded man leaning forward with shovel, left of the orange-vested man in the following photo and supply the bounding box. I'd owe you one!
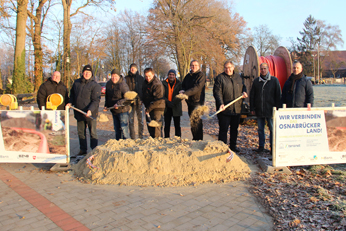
[143,68,165,138]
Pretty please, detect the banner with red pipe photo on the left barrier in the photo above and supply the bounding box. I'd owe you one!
[0,110,70,163]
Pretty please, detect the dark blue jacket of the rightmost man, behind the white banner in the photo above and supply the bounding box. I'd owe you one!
[281,75,314,108]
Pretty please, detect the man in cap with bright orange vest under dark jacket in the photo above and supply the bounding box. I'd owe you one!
[162,69,183,138]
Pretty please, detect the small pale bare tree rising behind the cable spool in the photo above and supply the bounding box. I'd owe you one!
[253,25,281,56]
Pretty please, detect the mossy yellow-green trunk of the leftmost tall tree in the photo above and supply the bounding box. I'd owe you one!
[12,0,28,94]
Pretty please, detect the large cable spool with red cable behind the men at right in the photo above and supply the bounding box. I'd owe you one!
[243,46,292,91]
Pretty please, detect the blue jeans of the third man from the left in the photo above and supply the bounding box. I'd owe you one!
[112,112,130,140]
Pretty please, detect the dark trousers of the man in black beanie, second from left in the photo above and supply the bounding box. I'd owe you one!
[77,120,98,152]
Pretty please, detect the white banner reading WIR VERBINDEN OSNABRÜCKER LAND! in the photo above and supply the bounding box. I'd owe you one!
[273,108,346,167]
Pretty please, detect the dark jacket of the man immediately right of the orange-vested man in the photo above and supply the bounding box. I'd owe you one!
[181,70,206,105]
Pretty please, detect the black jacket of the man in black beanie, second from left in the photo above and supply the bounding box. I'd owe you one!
[70,77,101,121]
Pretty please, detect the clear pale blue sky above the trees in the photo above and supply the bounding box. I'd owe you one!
[116,0,346,50]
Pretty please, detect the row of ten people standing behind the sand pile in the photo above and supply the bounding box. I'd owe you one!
[37,60,313,155]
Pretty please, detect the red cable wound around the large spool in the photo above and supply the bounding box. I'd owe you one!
[259,55,287,90]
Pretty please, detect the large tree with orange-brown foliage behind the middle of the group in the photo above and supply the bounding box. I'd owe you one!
[148,0,246,77]
